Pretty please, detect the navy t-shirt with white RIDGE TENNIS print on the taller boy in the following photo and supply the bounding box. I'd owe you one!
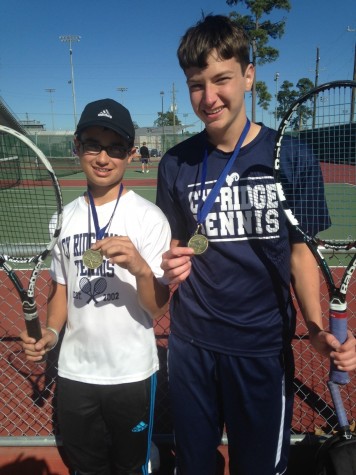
[157,126,303,357]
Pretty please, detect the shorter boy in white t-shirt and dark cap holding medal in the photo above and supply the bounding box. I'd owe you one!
[21,99,171,475]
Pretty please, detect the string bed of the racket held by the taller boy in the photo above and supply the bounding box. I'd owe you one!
[281,87,356,246]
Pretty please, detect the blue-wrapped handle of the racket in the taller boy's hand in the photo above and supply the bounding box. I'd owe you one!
[329,303,350,384]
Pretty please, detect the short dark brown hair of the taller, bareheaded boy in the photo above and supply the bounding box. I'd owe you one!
[177,15,250,73]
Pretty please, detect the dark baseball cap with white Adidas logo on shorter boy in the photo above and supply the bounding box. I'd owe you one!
[75,99,135,145]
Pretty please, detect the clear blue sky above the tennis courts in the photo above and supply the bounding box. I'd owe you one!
[0,0,356,132]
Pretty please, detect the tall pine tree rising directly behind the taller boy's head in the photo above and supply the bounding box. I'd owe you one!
[226,0,291,121]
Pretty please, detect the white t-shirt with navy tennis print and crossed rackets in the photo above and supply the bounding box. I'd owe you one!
[51,191,171,384]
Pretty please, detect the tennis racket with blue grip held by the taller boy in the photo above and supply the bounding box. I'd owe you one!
[274,80,356,434]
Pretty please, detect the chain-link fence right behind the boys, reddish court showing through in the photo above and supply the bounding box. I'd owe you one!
[0,256,356,445]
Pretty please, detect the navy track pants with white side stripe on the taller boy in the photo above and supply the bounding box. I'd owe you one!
[168,335,294,475]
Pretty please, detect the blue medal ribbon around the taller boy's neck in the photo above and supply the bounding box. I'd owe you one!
[197,119,251,227]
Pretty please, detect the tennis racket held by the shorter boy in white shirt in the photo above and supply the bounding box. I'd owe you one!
[0,126,63,341]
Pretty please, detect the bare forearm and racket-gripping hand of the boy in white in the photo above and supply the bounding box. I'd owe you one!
[20,281,67,361]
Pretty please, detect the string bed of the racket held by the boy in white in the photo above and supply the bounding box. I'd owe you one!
[0,134,58,257]
